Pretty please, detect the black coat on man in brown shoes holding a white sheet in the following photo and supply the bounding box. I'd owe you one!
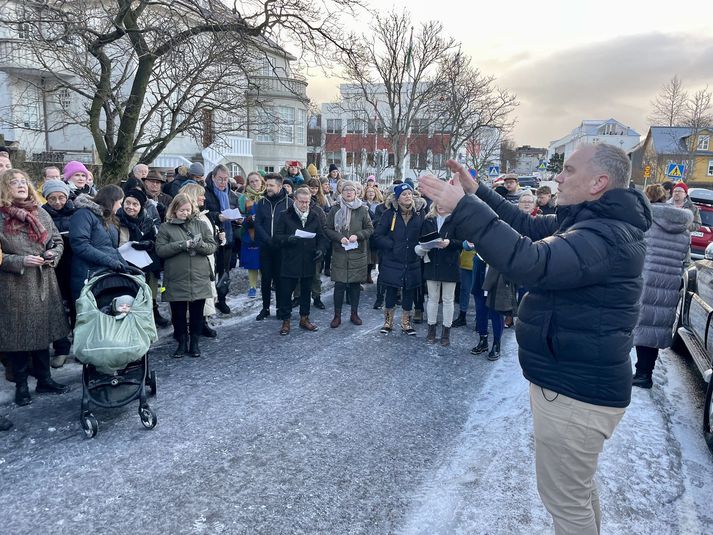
[273,206,327,279]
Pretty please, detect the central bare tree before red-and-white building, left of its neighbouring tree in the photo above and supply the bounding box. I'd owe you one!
[342,11,455,178]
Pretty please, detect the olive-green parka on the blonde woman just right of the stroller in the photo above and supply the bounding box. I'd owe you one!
[156,217,217,302]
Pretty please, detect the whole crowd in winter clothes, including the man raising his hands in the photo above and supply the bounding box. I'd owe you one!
[0,145,701,532]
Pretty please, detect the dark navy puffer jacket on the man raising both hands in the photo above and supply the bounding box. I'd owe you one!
[450,186,651,407]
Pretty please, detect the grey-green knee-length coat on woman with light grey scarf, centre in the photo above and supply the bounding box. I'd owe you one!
[324,204,374,283]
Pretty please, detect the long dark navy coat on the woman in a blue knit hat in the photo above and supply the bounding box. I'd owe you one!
[374,195,426,290]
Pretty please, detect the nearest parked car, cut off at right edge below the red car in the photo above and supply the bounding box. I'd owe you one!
[672,244,713,452]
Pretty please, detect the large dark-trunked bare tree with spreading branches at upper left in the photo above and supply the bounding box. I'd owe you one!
[0,0,360,181]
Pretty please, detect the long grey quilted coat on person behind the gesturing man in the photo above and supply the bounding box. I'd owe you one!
[634,203,693,349]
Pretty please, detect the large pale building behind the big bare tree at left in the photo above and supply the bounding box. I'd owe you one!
[0,2,308,176]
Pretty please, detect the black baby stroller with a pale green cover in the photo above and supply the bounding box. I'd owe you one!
[74,267,158,438]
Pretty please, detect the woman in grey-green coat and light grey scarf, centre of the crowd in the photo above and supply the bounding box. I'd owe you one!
[324,180,374,329]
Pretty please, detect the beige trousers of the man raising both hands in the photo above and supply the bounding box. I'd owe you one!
[530,383,624,535]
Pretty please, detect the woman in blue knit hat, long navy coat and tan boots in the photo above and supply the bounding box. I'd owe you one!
[374,183,426,335]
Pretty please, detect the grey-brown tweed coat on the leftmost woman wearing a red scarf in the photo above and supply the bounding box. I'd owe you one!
[0,209,69,352]
